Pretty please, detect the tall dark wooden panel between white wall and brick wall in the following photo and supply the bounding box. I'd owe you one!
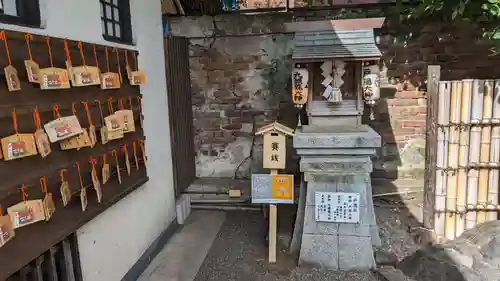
[165,37,196,196]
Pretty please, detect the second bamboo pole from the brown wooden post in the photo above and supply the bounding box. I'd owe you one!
[444,81,462,240]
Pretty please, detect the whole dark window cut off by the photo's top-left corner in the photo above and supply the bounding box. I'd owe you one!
[0,0,40,27]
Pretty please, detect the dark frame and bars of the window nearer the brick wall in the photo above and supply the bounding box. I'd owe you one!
[99,0,134,45]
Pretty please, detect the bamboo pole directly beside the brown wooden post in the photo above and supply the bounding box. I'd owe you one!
[434,82,451,241]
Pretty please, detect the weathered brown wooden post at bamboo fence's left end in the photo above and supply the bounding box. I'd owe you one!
[422,65,441,243]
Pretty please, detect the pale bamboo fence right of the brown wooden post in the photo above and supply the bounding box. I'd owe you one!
[430,75,500,241]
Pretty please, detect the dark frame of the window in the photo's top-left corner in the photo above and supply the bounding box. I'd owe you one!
[0,0,42,28]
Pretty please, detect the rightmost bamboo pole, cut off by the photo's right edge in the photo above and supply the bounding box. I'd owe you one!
[487,80,500,221]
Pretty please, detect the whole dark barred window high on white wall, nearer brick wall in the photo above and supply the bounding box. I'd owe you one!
[99,0,132,44]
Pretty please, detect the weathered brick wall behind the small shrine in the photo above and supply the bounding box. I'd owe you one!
[169,12,500,179]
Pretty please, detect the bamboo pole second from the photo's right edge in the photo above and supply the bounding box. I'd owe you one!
[476,81,493,224]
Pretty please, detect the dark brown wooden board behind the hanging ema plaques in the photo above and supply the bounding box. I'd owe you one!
[0,31,147,280]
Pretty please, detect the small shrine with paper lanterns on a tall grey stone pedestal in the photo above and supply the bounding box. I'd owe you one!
[286,18,384,270]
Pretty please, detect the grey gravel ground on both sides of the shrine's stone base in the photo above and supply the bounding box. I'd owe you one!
[195,196,418,281]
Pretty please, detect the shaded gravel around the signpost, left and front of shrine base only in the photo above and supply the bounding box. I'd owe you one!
[195,205,379,281]
